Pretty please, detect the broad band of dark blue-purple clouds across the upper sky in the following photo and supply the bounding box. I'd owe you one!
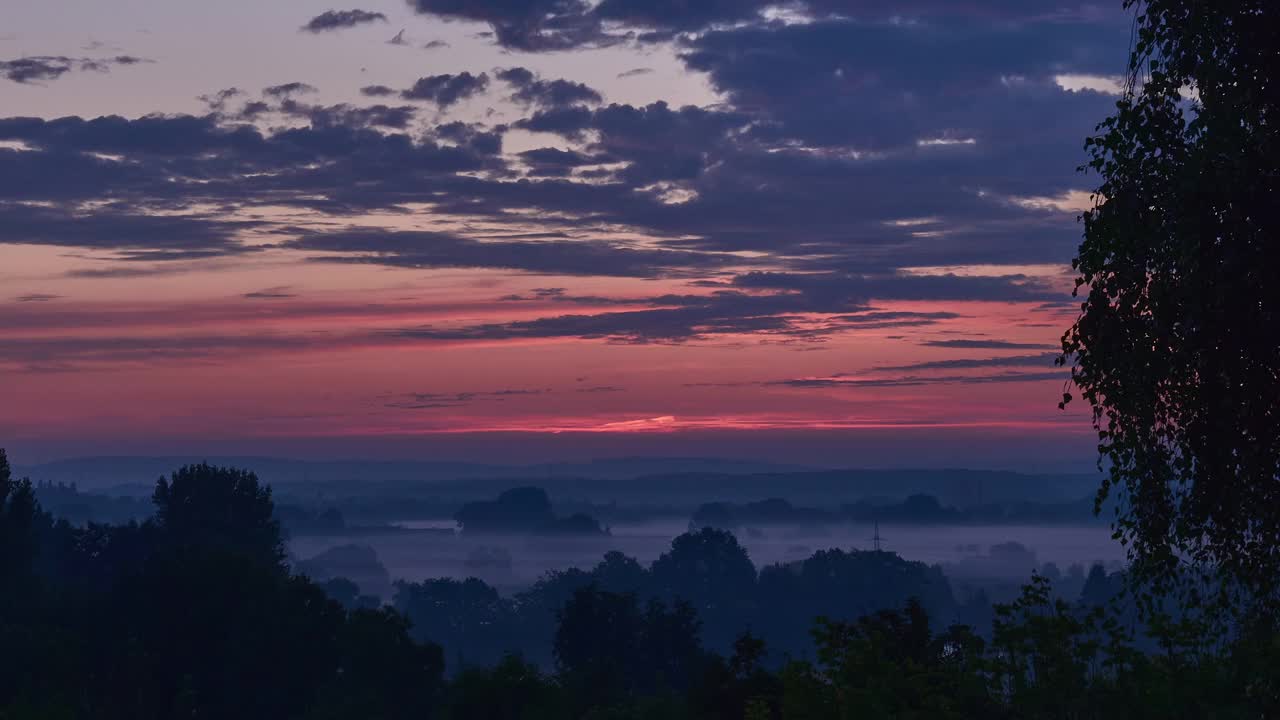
[0,0,1128,312]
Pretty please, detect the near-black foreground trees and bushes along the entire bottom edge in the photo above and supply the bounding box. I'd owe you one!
[0,452,1280,720]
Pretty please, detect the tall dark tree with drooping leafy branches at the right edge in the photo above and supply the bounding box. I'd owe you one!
[1062,0,1280,607]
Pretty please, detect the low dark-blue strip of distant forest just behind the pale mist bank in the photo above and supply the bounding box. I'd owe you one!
[24,471,1103,536]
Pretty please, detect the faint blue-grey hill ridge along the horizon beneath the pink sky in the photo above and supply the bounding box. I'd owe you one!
[17,456,1098,509]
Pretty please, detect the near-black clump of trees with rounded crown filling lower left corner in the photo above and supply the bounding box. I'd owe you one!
[0,451,443,720]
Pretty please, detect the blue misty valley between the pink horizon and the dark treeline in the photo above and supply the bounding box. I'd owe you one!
[22,457,1124,601]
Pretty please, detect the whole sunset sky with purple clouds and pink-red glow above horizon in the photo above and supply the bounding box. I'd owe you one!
[0,0,1132,470]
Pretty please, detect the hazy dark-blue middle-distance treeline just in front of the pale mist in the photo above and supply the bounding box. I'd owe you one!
[394,528,962,666]
